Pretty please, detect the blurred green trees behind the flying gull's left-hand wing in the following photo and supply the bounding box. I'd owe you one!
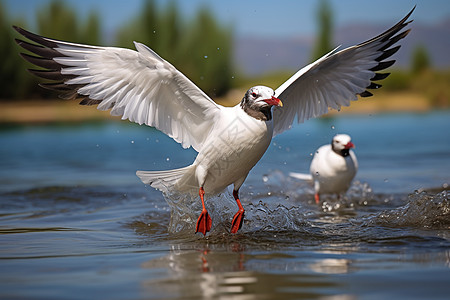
[0,0,233,100]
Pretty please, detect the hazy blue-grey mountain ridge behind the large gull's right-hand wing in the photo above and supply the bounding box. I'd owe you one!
[234,17,450,75]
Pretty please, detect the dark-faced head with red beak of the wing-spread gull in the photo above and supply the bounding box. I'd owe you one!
[241,85,283,121]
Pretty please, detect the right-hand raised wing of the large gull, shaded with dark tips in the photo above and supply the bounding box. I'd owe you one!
[273,7,415,135]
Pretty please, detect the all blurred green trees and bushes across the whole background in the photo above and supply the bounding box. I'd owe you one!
[0,0,450,107]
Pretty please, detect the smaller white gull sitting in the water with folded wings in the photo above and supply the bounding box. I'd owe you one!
[289,134,358,203]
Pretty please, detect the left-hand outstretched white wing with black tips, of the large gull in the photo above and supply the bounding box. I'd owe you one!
[14,27,221,151]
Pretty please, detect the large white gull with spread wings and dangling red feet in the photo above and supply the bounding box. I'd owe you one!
[14,8,414,235]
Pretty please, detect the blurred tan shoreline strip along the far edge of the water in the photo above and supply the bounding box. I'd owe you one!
[0,90,442,124]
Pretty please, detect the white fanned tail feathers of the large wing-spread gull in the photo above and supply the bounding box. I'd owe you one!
[136,165,196,192]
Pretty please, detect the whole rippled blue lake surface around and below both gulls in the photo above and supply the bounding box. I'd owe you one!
[0,111,450,299]
